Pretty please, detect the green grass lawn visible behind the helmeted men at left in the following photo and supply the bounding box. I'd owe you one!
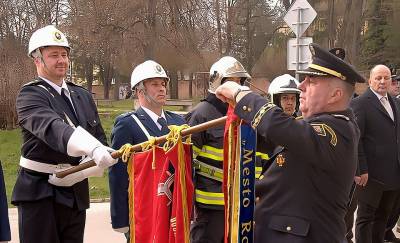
[0,99,186,206]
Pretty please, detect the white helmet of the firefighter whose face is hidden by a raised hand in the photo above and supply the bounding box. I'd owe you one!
[208,56,251,93]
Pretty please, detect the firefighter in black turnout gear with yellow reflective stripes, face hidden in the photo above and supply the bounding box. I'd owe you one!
[186,56,267,243]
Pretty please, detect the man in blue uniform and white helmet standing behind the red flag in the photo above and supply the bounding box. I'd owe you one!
[108,60,184,242]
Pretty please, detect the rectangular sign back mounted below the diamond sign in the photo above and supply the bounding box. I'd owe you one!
[287,37,312,71]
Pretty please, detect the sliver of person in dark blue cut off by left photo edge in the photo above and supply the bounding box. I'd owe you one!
[0,161,11,243]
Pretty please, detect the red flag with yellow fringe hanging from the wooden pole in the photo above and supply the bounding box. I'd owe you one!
[126,127,194,243]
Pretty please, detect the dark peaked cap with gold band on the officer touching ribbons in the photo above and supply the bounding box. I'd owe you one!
[297,43,365,84]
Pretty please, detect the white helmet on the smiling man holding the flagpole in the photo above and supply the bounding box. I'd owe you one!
[28,25,71,57]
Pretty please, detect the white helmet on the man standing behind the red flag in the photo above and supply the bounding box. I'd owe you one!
[131,60,169,89]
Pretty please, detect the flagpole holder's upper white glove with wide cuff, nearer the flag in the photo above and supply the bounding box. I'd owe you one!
[67,126,117,168]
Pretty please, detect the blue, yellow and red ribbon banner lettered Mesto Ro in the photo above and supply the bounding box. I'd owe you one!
[223,107,256,243]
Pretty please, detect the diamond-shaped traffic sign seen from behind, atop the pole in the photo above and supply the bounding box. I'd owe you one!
[283,0,317,37]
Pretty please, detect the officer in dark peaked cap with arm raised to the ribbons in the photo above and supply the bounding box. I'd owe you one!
[216,44,364,243]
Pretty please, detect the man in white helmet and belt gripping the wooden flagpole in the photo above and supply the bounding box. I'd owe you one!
[12,25,116,243]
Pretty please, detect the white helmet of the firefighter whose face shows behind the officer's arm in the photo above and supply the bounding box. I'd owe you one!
[268,74,300,105]
